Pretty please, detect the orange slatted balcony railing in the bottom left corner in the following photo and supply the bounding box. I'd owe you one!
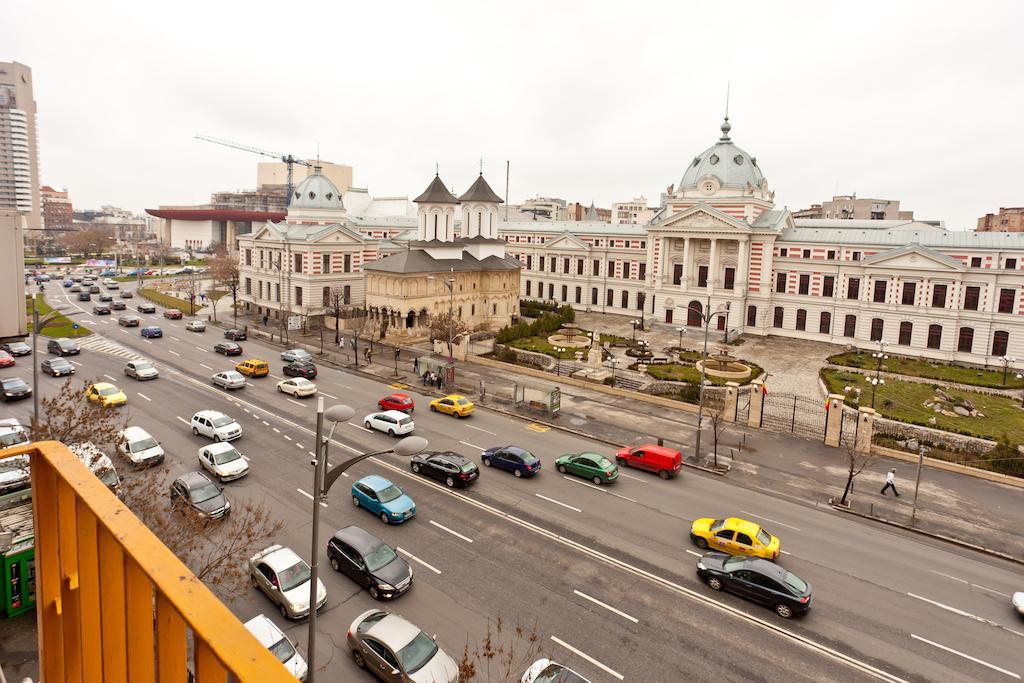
[3,441,295,683]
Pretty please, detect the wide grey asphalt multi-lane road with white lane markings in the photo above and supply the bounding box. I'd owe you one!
[6,285,1024,682]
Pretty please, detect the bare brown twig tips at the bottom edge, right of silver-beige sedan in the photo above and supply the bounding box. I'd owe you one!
[459,616,541,683]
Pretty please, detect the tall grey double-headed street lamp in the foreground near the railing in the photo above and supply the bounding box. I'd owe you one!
[306,396,427,683]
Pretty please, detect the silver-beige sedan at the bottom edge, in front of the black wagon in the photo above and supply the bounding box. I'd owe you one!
[348,609,459,683]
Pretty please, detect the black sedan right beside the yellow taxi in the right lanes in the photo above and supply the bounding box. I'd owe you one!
[697,552,811,618]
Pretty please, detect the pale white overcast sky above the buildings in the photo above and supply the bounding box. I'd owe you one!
[8,0,1024,229]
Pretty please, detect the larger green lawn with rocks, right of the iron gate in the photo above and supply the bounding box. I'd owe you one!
[821,370,1024,444]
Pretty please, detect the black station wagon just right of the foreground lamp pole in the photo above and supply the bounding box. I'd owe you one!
[327,526,413,600]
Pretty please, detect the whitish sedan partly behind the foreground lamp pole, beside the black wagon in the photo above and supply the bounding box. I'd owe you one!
[249,545,327,618]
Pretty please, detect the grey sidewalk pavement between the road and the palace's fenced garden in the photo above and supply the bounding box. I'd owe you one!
[240,317,1024,562]
